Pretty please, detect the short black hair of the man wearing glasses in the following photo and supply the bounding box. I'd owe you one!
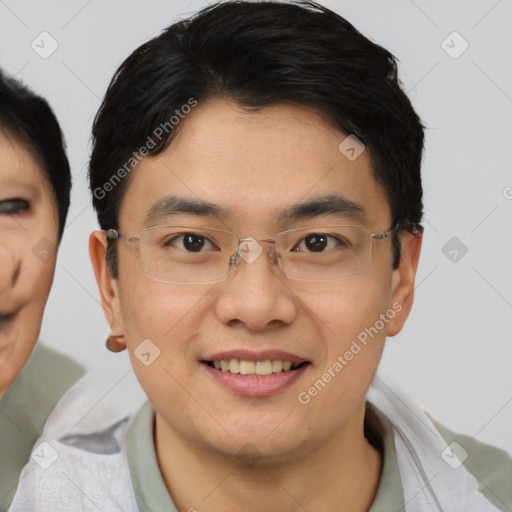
[89,1,424,276]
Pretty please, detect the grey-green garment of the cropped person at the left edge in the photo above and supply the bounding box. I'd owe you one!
[0,342,85,512]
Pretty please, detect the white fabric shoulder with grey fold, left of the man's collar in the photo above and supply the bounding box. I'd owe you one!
[9,412,137,512]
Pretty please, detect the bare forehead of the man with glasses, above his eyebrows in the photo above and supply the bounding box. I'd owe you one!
[120,100,390,234]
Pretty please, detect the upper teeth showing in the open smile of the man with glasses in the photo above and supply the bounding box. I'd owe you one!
[201,359,311,377]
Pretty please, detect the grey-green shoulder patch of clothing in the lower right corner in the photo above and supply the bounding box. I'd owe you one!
[429,416,512,512]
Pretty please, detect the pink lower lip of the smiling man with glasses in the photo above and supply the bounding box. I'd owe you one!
[201,363,309,397]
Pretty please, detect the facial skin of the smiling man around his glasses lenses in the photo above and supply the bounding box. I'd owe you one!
[94,100,418,458]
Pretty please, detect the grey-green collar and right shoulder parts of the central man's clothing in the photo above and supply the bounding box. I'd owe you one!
[127,402,512,512]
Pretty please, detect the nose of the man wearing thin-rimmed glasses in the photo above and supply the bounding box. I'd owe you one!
[215,239,298,331]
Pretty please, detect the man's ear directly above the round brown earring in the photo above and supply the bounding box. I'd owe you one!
[89,230,124,337]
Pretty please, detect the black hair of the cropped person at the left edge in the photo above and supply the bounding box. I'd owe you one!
[0,70,71,240]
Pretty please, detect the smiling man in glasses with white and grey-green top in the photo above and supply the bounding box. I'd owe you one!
[5,1,512,512]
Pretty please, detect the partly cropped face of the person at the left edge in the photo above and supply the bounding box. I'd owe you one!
[0,134,58,398]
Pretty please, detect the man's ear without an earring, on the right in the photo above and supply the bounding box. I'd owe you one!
[387,231,423,336]
